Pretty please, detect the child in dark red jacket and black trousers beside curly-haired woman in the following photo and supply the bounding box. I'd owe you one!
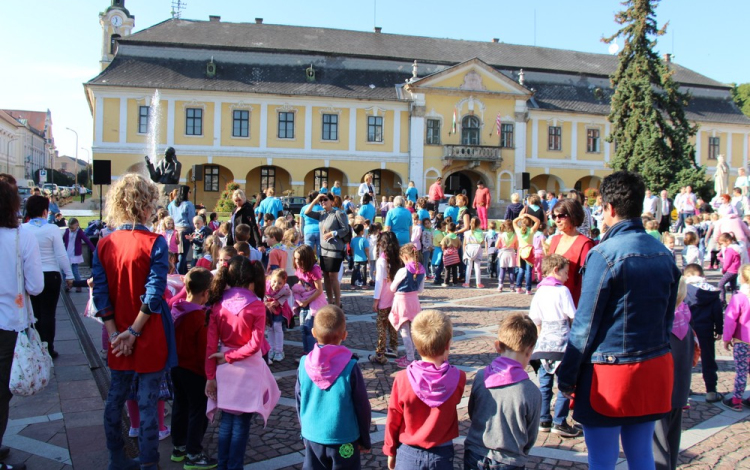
[172,268,217,468]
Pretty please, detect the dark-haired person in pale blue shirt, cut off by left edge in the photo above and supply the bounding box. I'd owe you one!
[0,173,44,470]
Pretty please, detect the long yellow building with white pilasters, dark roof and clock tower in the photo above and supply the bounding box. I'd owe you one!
[85,0,750,210]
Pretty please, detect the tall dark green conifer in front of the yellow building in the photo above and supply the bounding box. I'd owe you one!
[602,0,709,195]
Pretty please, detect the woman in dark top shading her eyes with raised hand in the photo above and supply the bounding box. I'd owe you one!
[304,194,351,307]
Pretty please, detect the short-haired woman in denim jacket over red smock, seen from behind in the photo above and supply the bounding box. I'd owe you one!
[557,171,680,470]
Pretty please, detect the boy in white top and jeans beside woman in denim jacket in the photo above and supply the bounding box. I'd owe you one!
[529,254,581,438]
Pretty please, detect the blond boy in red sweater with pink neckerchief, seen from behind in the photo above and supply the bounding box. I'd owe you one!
[383,310,466,470]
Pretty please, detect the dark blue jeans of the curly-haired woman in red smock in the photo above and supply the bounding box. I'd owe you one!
[104,370,164,468]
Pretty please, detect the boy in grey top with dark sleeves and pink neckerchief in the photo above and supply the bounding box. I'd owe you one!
[464,314,542,470]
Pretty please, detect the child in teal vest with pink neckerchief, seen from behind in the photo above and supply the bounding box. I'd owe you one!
[295,305,371,470]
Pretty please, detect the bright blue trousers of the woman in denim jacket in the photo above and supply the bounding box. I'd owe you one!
[583,421,656,470]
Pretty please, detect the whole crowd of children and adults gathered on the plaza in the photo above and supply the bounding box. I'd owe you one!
[0,172,750,469]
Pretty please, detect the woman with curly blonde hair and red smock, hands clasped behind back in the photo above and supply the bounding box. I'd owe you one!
[92,174,177,470]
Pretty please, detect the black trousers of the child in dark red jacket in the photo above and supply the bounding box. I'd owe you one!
[172,367,208,455]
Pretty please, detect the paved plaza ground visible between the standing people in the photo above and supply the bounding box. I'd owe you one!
[4,262,750,470]
